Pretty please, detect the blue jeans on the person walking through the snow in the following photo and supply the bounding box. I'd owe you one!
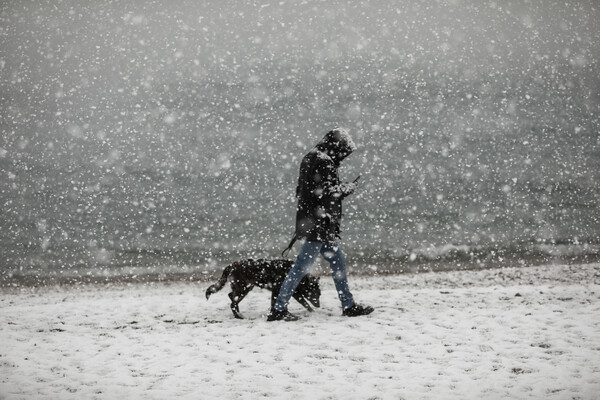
[274,242,354,311]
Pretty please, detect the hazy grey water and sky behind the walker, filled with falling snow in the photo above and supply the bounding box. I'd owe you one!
[0,0,600,282]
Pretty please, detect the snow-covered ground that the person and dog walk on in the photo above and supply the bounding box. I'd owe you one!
[0,264,600,399]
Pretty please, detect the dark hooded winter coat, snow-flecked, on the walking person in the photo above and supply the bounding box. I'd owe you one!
[296,129,356,243]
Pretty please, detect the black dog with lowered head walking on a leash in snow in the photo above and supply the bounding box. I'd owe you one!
[206,260,321,319]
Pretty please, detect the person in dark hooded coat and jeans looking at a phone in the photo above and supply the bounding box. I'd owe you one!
[267,128,373,321]
